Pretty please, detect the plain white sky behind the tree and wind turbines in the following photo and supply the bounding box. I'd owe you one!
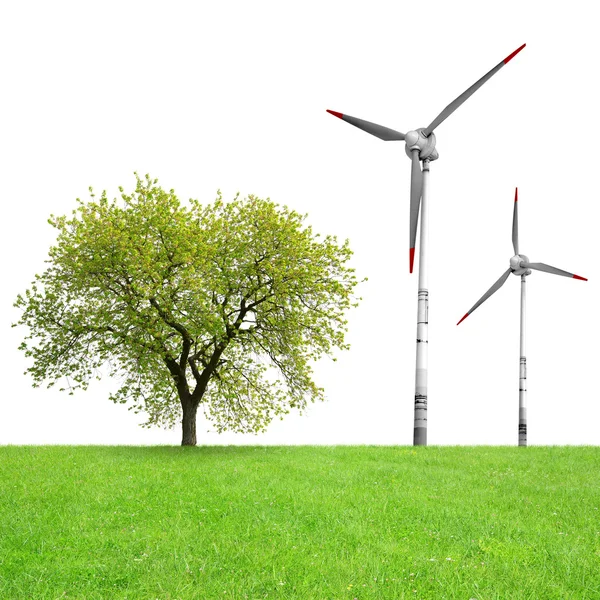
[0,0,600,445]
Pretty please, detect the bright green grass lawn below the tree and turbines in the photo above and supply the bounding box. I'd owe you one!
[0,446,600,600]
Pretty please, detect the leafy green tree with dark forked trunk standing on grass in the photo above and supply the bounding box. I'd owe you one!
[13,174,358,445]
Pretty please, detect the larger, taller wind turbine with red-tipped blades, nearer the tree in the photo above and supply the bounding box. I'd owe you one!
[327,44,525,446]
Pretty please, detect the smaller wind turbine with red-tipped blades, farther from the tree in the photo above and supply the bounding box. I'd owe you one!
[457,188,587,446]
